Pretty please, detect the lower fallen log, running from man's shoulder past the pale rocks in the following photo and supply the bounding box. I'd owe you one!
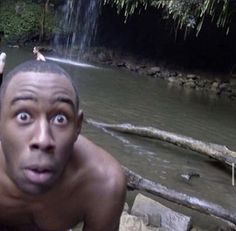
[123,166,236,226]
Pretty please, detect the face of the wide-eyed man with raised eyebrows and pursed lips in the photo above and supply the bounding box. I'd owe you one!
[0,72,82,195]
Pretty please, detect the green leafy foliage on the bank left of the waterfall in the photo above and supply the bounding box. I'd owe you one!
[0,0,55,44]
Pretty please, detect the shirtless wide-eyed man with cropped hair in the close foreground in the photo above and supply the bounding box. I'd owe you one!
[0,61,126,231]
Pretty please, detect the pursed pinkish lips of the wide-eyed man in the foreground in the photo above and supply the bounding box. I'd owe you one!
[24,166,54,184]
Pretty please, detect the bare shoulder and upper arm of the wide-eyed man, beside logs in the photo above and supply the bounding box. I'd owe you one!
[76,136,126,231]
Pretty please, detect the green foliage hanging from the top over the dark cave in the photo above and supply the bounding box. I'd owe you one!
[104,0,235,34]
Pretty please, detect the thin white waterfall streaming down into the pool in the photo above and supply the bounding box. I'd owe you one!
[54,0,101,60]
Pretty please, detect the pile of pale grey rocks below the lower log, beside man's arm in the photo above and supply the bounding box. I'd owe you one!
[119,194,191,231]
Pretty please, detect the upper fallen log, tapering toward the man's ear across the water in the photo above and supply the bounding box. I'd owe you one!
[86,119,236,167]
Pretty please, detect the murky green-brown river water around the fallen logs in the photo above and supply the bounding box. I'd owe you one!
[3,49,236,230]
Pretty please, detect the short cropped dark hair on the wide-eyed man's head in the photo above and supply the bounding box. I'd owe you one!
[0,60,79,109]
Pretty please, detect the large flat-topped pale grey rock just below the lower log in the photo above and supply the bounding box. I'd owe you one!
[131,194,191,231]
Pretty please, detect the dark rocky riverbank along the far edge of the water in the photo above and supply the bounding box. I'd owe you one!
[78,48,236,100]
